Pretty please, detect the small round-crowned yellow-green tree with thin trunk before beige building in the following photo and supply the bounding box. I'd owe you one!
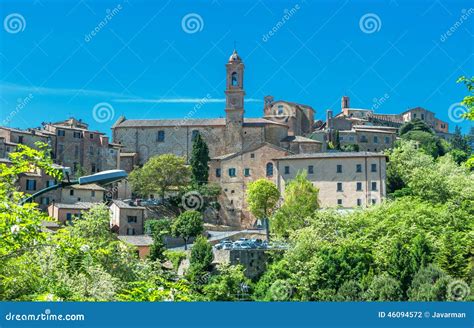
[247,179,280,219]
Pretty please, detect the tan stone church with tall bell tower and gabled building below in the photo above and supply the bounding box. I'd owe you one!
[112,50,386,227]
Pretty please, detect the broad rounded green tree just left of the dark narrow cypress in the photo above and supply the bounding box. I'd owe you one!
[129,154,190,200]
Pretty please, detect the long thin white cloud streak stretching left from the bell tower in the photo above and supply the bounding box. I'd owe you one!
[0,81,262,104]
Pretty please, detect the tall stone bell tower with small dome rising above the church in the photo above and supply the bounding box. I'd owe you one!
[225,50,245,153]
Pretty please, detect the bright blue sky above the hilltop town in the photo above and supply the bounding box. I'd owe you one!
[0,0,474,133]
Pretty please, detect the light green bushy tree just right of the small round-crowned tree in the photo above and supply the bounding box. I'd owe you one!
[271,171,319,237]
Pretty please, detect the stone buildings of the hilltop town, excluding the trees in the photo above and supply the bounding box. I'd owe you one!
[0,50,462,255]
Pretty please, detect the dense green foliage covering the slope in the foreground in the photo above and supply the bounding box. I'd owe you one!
[0,129,474,301]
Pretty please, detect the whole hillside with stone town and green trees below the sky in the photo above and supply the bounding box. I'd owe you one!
[0,43,474,301]
